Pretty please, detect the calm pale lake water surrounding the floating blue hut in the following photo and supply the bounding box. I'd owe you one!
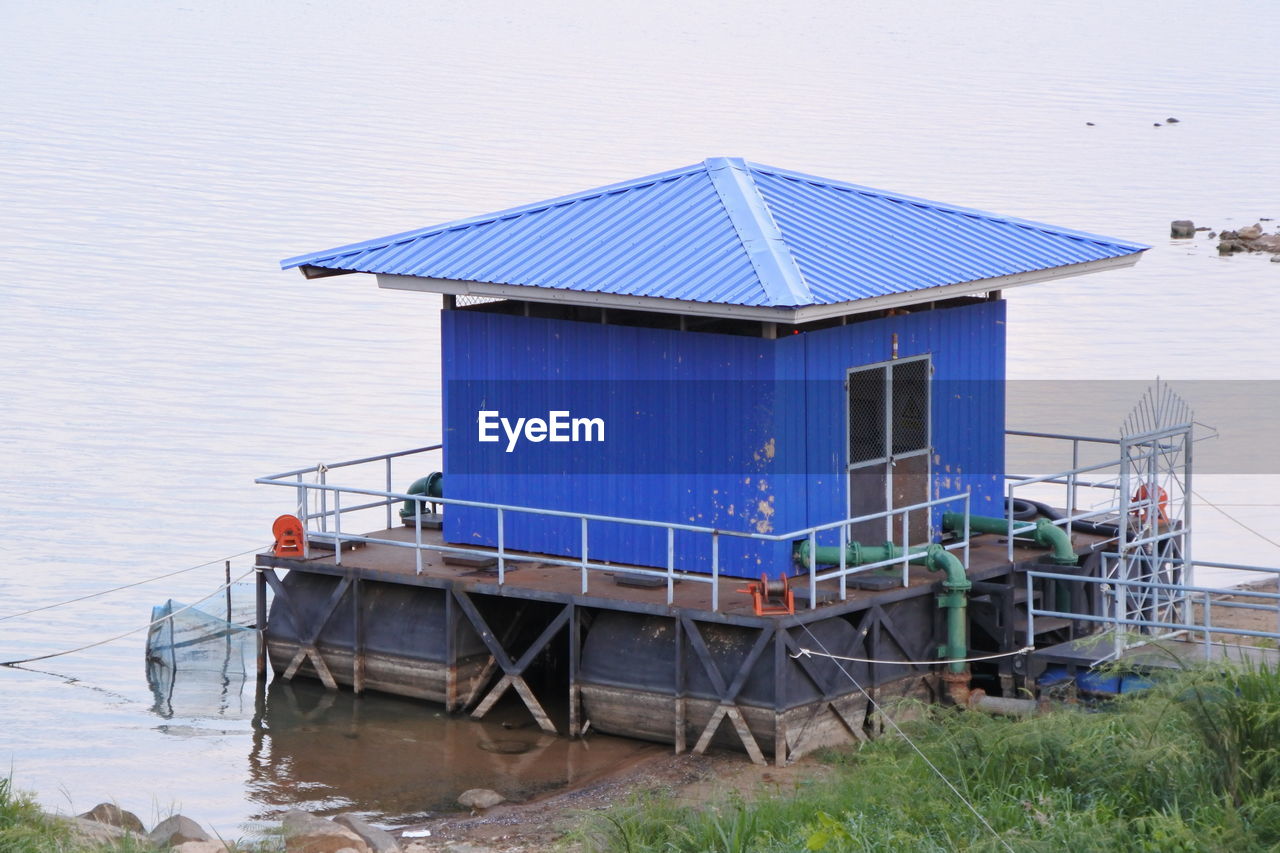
[0,0,1280,836]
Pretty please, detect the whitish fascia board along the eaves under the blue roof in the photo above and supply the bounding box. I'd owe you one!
[368,252,1142,325]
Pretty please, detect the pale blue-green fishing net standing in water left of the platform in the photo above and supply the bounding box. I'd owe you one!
[147,589,257,719]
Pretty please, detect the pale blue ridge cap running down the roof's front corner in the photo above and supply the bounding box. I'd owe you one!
[704,158,813,306]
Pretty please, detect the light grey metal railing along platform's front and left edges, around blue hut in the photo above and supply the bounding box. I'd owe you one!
[255,444,970,611]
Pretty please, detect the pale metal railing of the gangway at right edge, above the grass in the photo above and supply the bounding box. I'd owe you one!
[1027,555,1280,665]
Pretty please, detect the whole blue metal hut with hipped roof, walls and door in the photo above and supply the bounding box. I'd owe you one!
[283,158,1146,576]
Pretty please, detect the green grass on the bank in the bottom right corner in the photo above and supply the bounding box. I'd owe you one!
[571,669,1280,853]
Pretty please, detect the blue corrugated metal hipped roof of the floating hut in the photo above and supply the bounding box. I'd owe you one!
[282,158,1148,307]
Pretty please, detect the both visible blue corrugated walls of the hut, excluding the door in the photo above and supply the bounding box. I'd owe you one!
[442,302,1005,578]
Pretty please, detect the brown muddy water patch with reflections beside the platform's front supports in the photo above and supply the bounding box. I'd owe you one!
[241,679,666,825]
